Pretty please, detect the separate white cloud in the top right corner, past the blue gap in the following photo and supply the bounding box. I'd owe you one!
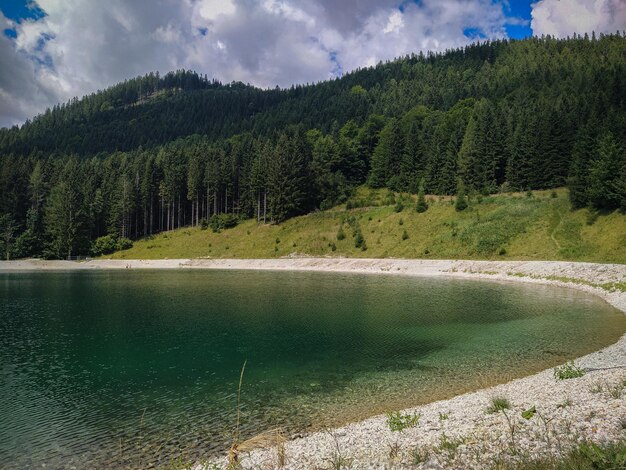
[531,0,626,37]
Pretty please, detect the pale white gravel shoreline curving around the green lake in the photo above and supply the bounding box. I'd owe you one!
[0,257,626,470]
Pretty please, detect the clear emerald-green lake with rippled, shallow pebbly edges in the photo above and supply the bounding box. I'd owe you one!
[0,270,626,469]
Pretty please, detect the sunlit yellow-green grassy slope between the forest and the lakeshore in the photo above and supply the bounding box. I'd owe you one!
[111,188,626,263]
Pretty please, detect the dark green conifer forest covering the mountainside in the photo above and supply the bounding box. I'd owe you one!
[0,32,626,259]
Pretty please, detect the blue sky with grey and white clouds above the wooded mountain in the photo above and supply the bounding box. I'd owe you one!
[0,0,626,127]
